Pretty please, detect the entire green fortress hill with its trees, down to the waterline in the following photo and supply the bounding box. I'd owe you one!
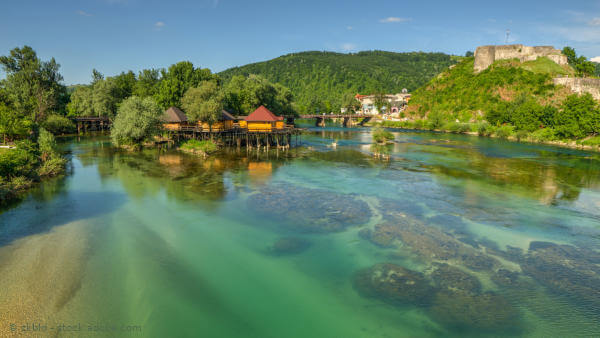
[394,47,600,145]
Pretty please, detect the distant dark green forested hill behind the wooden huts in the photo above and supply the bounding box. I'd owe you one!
[219,51,456,111]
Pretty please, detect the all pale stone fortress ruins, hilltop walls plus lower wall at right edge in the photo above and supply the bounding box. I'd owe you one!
[473,45,600,100]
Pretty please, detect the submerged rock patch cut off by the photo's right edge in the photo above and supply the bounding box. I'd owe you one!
[521,242,600,311]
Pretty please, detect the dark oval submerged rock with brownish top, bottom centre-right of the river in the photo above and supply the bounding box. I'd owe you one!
[354,263,435,306]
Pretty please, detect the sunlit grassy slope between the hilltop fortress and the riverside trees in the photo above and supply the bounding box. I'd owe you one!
[408,58,573,122]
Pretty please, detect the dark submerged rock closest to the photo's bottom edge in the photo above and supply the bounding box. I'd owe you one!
[430,290,518,330]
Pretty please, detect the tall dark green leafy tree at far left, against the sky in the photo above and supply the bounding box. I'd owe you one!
[0,46,66,123]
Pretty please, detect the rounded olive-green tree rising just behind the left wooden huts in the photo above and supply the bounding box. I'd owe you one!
[181,81,224,131]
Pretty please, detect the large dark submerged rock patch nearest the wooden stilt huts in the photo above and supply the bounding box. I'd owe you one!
[248,185,371,232]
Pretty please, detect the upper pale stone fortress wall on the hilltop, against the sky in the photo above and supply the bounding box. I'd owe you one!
[474,45,568,73]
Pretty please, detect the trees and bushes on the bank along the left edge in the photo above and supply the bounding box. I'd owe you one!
[0,46,71,204]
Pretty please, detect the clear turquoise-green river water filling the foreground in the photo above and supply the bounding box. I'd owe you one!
[0,128,600,337]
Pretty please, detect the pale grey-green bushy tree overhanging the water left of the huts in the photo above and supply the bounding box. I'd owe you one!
[110,96,163,145]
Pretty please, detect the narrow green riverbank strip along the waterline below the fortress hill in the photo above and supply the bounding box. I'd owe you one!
[365,120,600,152]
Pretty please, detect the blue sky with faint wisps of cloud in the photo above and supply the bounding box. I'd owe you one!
[0,0,600,85]
